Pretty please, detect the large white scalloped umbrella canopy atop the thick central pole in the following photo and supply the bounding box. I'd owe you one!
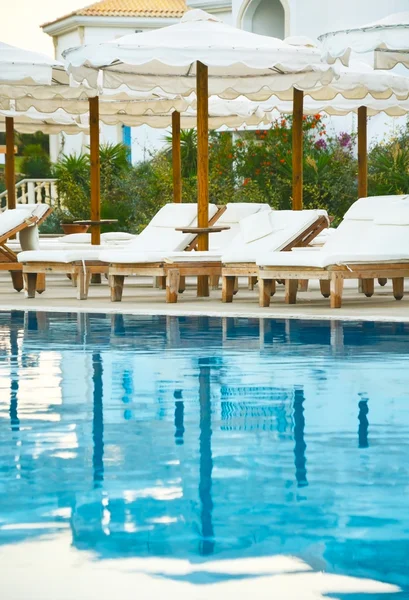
[64,10,333,100]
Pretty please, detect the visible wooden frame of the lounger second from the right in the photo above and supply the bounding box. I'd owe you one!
[221,215,328,302]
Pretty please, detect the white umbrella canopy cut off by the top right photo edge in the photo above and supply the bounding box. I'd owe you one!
[318,12,409,69]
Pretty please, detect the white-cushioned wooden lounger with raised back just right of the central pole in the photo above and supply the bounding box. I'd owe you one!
[105,203,271,302]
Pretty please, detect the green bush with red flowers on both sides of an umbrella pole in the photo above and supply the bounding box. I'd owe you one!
[235,114,356,221]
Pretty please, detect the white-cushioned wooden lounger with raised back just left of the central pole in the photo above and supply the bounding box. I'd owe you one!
[18,203,222,300]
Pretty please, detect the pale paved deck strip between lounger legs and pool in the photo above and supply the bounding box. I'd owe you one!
[0,273,409,322]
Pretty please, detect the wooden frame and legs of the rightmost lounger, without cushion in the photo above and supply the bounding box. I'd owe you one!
[258,262,409,308]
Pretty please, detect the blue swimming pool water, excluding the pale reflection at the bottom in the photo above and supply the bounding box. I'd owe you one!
[0,311,409,600]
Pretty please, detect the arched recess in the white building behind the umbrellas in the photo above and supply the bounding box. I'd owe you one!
[239,0,288,39]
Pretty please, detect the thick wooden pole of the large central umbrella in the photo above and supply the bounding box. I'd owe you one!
[196,61,209,296]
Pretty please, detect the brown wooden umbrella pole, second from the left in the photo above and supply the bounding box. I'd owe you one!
[89,96,101,246]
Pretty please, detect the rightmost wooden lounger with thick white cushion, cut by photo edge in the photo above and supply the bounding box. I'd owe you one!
[257,196,409,308]
